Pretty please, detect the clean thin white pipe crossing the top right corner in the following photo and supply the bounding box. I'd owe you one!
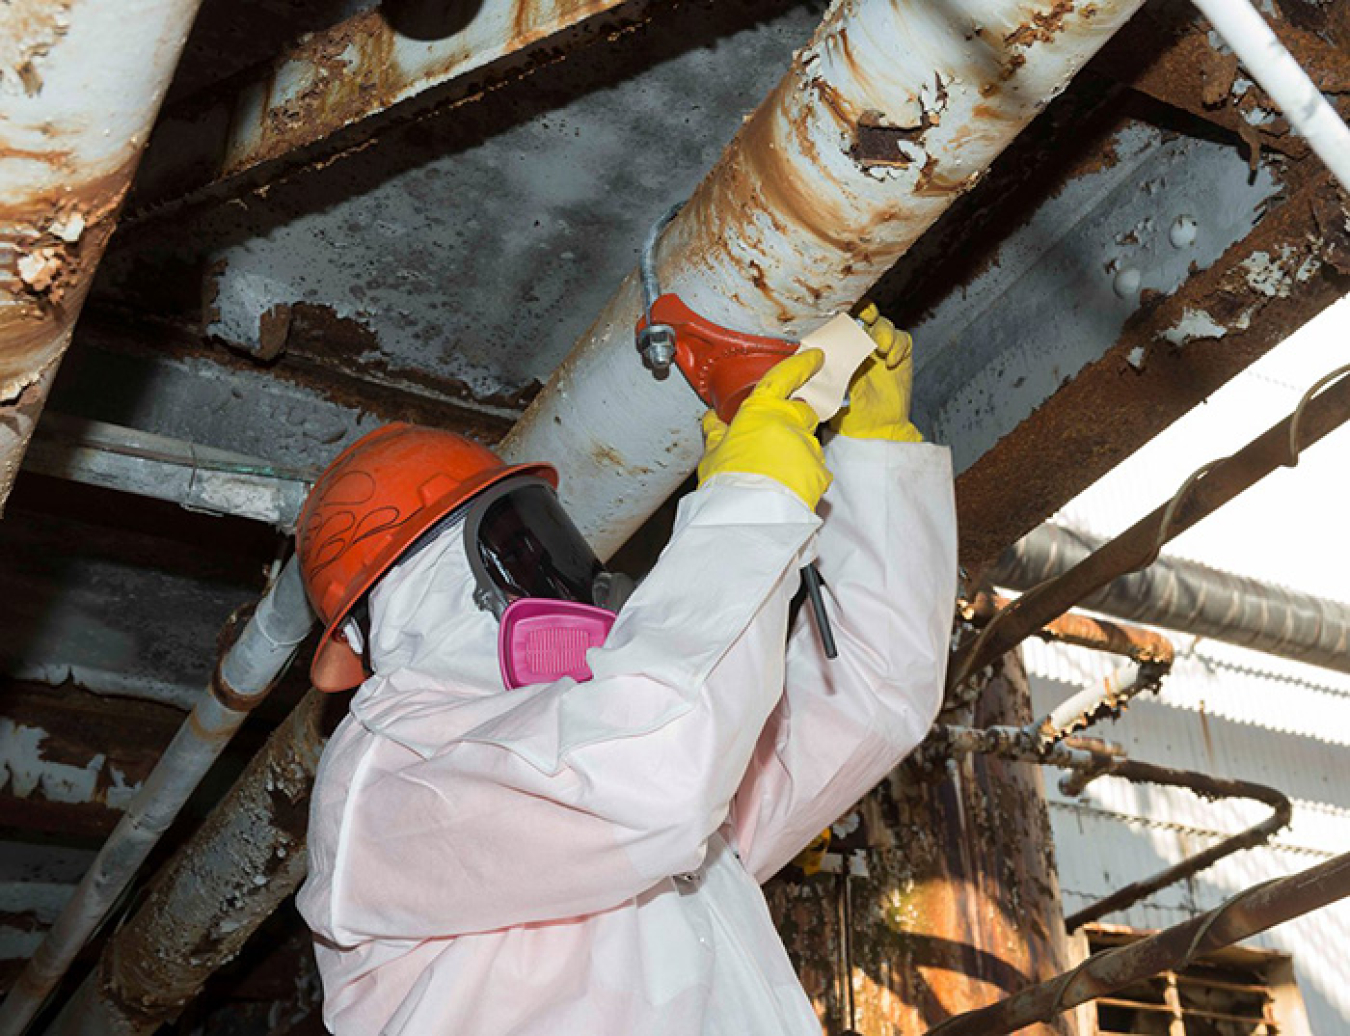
[1193,0,1350,192]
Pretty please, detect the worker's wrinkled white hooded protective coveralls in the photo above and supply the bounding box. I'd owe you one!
[298,438,956,1036]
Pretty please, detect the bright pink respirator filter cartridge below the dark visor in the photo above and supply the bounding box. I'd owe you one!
[497,597,617,690]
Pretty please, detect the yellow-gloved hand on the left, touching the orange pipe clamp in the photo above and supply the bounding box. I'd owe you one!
[698,348,833,511]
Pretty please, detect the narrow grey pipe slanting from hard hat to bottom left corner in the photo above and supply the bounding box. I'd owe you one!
[0,558,313,1036]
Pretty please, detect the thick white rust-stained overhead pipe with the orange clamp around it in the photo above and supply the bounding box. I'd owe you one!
[502,0,1142,556]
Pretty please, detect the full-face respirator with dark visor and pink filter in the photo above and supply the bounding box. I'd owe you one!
[464,475,633,688]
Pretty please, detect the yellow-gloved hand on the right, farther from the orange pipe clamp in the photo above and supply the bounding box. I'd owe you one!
[830,304,923,443]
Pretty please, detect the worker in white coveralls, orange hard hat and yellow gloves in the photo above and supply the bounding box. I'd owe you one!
[297,311,956,1036]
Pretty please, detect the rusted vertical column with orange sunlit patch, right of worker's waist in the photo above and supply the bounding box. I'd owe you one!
[767,656,1075,1036]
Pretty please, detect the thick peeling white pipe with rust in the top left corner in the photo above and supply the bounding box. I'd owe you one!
[0,0,200,507]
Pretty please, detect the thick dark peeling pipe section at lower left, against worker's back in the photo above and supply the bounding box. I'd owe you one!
[47,690,332,1036]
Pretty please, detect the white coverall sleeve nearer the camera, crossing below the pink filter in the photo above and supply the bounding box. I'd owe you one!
[317,478,819,944]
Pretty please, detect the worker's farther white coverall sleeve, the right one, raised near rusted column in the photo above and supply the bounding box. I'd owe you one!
[733,436,956,882]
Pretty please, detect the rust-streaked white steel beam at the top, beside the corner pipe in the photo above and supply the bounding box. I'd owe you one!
[132,0,648,219]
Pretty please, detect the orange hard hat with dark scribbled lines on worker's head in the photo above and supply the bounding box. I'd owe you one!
[296,424,558,690]
